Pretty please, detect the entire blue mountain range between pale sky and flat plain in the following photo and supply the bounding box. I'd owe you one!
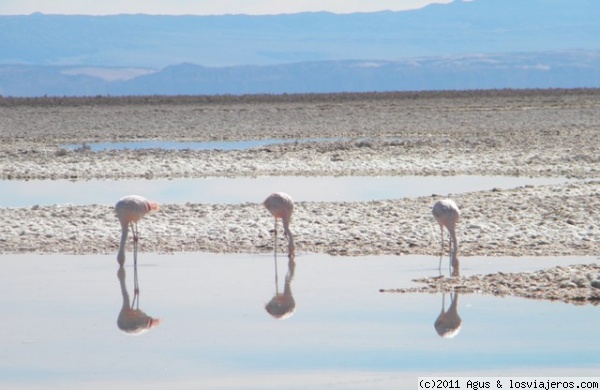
[0,0,600,96]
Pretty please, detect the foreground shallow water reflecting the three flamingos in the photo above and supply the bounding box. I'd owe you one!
[0,253,600,389]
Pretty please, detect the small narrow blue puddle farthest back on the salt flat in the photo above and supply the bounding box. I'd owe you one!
[61,138,341,152]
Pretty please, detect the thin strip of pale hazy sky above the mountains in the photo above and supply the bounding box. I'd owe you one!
[0,0,452,15]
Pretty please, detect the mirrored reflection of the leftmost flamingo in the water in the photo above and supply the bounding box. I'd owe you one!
[117,262,160,335]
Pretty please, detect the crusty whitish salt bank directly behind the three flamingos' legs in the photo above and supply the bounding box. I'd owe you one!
[0,181,600,256]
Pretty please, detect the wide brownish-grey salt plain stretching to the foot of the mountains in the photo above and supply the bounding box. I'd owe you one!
[0,90,600,180]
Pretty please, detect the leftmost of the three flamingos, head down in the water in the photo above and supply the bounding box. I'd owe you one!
[115,195,159,267]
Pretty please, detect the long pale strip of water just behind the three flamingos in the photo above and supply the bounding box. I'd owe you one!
[0,176,567,207]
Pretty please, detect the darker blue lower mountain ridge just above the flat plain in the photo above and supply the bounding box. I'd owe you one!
[0,51,600,96]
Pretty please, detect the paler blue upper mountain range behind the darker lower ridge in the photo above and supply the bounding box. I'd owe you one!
[0,0,600,68]
